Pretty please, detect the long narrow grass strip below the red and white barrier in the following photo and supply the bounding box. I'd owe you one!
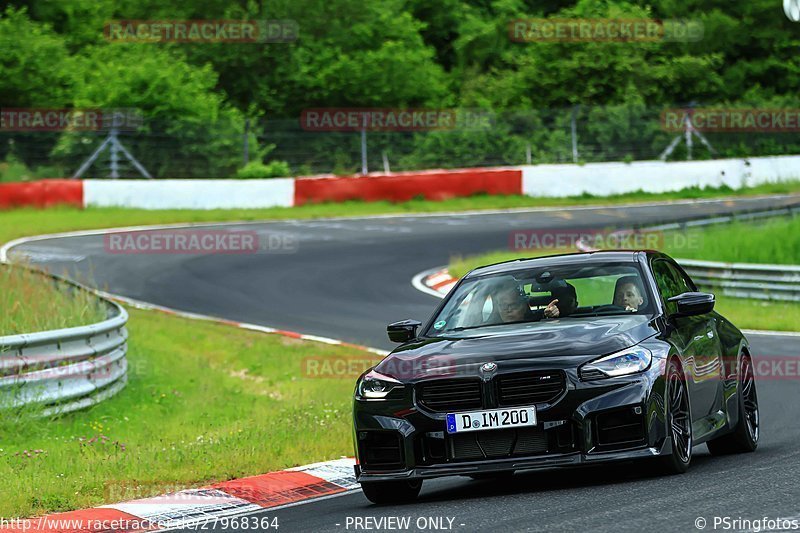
[0,180,800,246]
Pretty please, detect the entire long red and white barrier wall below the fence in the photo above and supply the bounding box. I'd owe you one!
[0,156,800,209]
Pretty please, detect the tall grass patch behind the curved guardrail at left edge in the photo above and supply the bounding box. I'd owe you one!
[0,265,106,336]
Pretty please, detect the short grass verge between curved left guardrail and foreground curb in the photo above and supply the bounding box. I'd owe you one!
[0,310,377,517]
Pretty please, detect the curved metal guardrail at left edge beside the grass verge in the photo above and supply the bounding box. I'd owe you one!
[0,267,128,416]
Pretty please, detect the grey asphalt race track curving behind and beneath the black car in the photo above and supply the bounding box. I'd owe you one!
[11,196,800,531]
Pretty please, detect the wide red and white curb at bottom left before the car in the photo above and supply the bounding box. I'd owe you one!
[0,458,359,533]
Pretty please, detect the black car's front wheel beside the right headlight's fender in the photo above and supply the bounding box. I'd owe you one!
[656,359,692,475]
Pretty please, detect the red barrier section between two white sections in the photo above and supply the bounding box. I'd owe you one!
[294,168,522,205]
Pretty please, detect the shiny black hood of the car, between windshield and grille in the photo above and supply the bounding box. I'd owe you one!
[375,315,658,382]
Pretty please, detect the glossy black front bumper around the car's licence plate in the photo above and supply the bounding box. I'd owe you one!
[353,359,672,481]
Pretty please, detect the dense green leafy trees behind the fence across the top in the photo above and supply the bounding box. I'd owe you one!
[0,0,800,177]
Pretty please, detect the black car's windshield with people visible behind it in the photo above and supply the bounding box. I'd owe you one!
[426,263,652,337]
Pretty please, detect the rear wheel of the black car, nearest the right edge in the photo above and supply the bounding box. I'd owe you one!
[706,354,760,455]
